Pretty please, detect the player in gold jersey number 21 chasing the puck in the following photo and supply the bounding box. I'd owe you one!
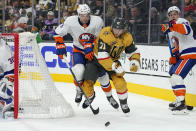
[82,17,140,113]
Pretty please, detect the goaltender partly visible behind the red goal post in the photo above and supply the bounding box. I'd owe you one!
[0,38,14,113]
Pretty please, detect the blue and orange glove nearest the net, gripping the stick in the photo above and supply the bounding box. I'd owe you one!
[56,42,67,59]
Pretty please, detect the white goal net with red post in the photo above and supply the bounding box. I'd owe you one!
[0,32,73,118]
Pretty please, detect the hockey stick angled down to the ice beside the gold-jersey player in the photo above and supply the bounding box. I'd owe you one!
[63,56,99,115]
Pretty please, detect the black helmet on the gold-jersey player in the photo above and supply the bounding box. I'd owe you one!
[112,17,128,30]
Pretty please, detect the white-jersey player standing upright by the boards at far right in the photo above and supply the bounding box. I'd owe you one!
[162,6,196,114]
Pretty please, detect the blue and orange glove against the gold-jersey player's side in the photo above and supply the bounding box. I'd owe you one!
[84,42,94,61]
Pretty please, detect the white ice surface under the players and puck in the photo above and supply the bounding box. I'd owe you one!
[0,83,196,131]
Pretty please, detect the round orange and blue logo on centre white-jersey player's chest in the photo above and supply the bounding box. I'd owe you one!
[78,33,95,45]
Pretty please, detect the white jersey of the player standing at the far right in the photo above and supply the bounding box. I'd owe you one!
[168,18,196,59]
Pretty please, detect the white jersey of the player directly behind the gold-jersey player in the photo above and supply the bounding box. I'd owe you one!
[55,15,103,49]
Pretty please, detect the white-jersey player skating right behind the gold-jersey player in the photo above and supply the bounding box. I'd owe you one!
[54,4,119,108]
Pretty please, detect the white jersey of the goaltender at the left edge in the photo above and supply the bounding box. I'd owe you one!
[0,39,14,79]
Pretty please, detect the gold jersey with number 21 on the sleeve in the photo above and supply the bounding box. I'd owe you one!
[94,27,140,71]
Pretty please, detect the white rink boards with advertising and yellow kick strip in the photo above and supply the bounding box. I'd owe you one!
[39,43,196,106]
